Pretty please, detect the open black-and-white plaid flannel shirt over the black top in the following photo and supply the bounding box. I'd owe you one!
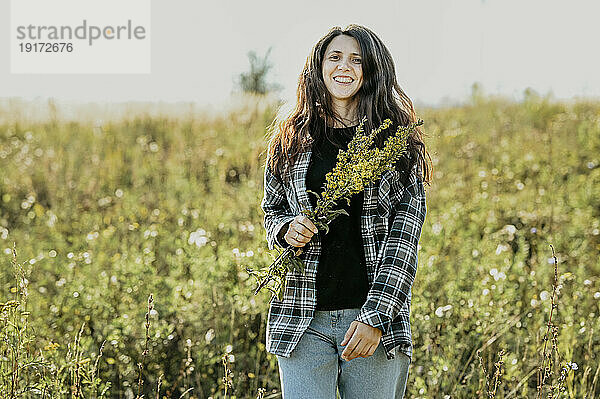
[261,150,427,359]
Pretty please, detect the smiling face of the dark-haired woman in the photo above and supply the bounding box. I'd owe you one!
[321,35,362,105]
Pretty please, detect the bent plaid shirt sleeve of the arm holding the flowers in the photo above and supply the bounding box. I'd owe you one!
[260,165,295,249]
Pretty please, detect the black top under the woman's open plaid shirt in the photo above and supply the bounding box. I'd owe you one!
[306,126,369,310]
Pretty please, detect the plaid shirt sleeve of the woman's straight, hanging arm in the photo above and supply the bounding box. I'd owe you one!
[356,171,427,334]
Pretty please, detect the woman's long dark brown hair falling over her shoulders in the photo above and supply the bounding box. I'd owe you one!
[266,24,431,184]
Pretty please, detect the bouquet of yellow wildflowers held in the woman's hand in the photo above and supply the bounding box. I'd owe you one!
[246,116,423,300]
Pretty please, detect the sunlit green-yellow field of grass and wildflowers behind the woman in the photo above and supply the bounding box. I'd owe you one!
[0,93,600,399]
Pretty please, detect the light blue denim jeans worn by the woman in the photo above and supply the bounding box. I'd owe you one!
[277,309,410,399]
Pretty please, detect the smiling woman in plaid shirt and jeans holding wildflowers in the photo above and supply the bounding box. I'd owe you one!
[261,25,430,399]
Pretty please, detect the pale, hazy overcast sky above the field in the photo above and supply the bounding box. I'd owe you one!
[0,0,600,105]
